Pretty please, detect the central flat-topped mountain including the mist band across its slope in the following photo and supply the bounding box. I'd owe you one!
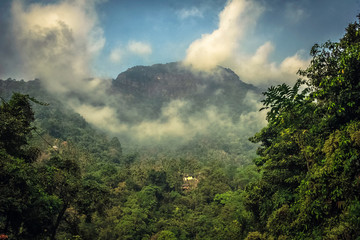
[103,62,265,162]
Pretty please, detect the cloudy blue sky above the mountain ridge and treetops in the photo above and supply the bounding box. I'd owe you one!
[0,0,360,87]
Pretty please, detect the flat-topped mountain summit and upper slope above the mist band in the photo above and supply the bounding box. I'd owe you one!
[111,62,260,120]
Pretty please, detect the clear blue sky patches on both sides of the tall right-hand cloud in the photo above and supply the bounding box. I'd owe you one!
[99,0,360,64]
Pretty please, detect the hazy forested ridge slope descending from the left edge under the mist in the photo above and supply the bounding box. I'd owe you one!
[0,79,122,162]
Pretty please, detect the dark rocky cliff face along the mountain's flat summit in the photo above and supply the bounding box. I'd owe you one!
[113,62,256,99]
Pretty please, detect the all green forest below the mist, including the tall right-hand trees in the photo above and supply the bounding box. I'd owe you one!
[0,14,360,240]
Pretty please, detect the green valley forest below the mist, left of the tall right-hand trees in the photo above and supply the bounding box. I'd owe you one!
[0,89,258,239]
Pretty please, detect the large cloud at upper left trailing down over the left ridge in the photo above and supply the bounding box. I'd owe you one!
[7,0,125,134]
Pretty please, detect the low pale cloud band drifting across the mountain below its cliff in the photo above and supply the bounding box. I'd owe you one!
[90,92,266,147]
